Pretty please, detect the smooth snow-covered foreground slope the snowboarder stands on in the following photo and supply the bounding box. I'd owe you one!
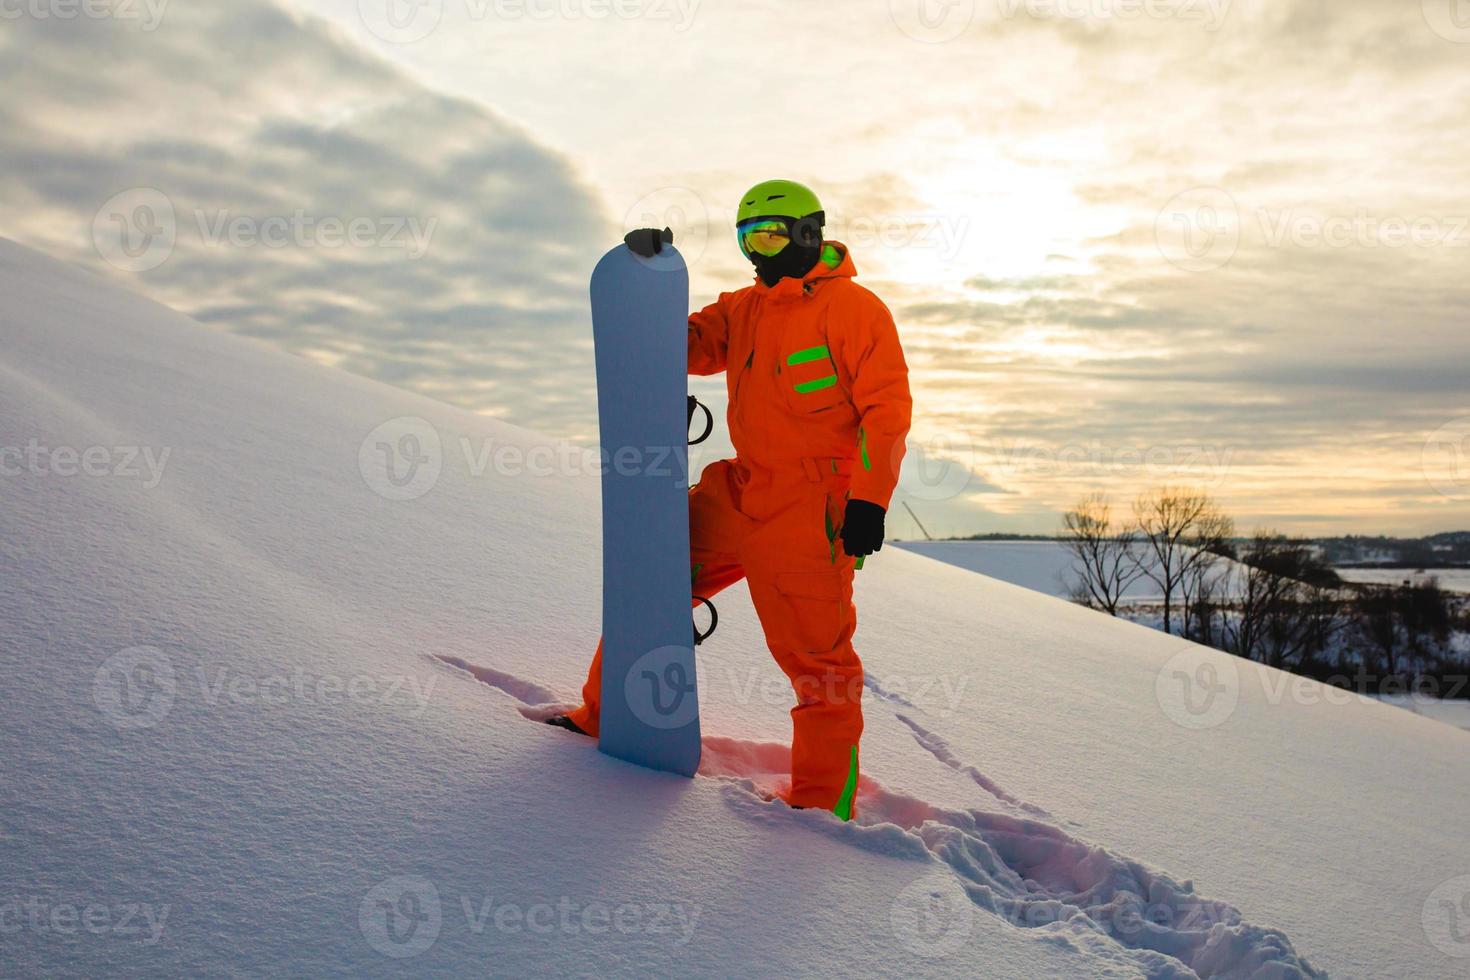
[0,239,1470,977]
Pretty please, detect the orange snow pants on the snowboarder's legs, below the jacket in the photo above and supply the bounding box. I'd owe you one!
[570,460,863,820]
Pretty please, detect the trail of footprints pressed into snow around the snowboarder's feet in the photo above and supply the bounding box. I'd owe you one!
[435,657,1326,980]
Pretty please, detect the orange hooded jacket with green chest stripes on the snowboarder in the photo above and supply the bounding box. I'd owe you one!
[689,242,913,507]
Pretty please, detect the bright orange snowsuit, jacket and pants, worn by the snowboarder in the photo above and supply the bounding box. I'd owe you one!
[570,242,911,820]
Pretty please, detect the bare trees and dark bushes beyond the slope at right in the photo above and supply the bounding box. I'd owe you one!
[1061,488,1470,698]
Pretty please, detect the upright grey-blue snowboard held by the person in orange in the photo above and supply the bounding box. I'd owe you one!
[591,245,700,776]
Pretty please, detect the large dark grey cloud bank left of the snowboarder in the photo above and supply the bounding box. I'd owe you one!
[0,0,612,435]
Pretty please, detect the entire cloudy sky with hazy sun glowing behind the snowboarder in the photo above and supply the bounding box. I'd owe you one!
[0,0,1470,536]
